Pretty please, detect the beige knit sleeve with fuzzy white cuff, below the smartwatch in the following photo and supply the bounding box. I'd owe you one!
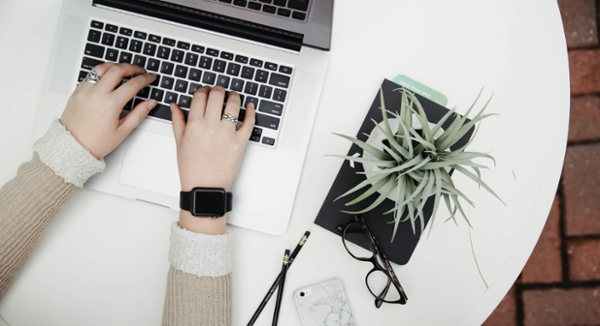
[163,223,231,326]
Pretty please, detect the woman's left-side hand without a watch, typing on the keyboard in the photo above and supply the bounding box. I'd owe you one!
[60,63,156,159]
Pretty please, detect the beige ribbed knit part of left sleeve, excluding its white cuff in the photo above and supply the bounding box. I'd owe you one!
[0,154,76,297]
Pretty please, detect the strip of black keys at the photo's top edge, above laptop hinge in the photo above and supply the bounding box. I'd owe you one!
[207,0,310,21]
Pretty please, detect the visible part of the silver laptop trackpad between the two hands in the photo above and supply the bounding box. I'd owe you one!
[119,129,181,197]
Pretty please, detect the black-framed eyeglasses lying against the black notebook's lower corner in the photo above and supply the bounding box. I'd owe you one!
[342,215,408,308]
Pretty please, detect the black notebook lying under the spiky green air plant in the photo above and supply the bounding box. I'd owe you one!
[315,79,475,265]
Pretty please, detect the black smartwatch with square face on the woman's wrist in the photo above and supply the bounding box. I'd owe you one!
[179,187,233,218]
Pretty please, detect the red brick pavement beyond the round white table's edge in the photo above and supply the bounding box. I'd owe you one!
[484,0,600,326]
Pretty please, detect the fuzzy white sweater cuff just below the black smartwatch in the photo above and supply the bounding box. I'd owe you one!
[169,222,231,277]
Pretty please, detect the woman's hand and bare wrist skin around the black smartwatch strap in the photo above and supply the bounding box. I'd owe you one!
[171,86,255,234]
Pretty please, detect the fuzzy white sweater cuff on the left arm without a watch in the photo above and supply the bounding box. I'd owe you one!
[33,119,106,188]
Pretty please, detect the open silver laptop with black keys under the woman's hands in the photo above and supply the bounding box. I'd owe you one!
[33,0,333,235]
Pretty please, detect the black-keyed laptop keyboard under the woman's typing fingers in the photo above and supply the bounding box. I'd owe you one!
[79,19,293,148]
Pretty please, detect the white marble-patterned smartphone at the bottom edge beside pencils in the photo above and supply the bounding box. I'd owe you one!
[293,278,356,326]
